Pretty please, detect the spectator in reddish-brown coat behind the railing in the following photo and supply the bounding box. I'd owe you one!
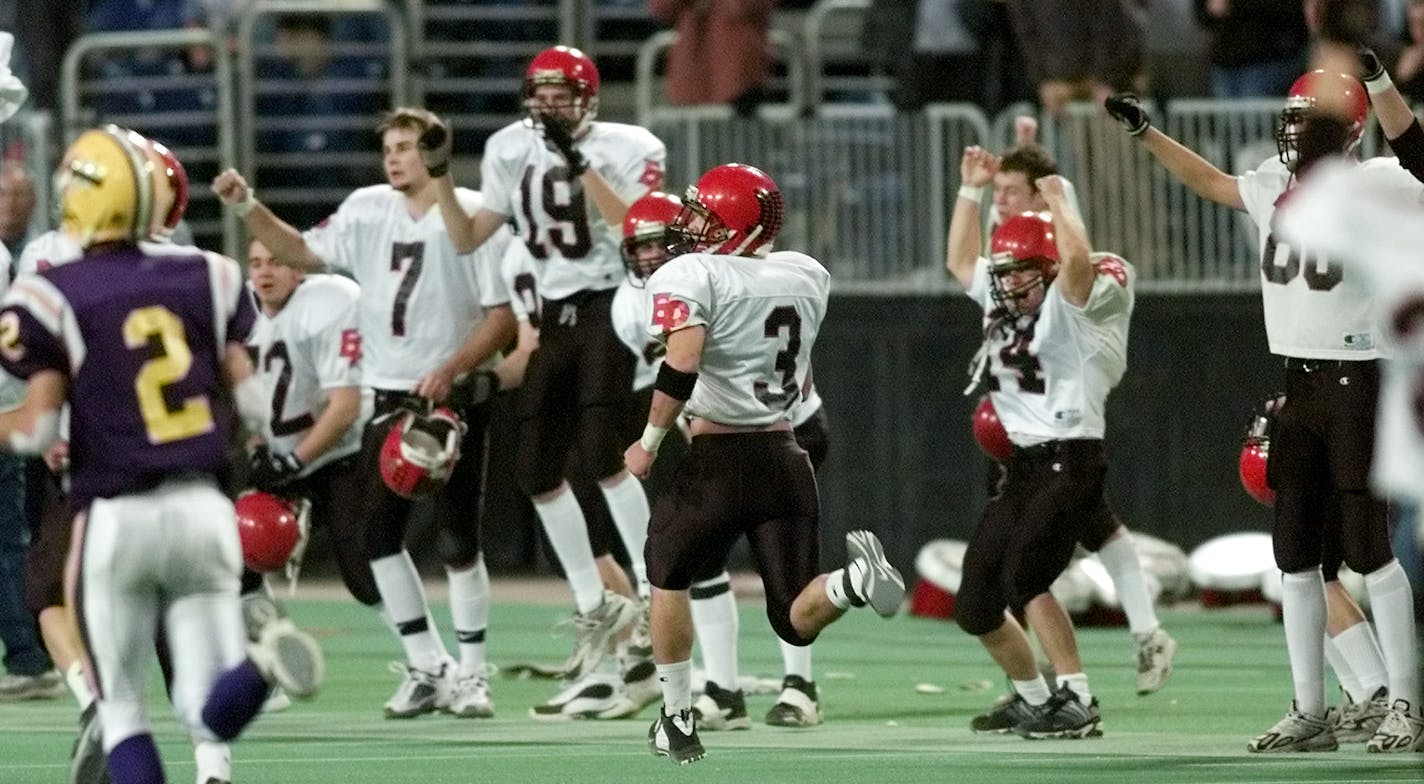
[649,0,776,117]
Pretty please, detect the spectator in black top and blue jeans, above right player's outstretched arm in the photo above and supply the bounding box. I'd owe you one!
[1195,0,1310,98]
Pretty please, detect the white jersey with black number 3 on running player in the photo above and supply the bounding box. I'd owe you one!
[644,250,830,425]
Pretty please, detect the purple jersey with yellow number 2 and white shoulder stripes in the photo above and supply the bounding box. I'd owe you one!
[0,241,255,504]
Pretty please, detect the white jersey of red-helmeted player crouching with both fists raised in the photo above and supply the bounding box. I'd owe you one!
[965,253,1136,447]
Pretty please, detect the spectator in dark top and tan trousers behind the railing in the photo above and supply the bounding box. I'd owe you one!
[1007,0,1146,114]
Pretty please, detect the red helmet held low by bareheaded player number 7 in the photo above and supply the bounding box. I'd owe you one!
[380,408,464,498]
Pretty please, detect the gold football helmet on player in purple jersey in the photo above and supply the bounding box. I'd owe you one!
[54,125,154,248]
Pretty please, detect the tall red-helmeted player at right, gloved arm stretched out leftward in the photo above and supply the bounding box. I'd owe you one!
[1104,70,1418,753]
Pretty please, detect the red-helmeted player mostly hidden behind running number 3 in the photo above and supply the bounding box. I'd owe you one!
[612,191,829,730]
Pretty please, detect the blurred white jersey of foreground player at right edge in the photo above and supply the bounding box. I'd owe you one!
[1277,159,1424,501]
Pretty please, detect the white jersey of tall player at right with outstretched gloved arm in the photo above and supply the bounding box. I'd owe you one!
[1236,158,1418,360]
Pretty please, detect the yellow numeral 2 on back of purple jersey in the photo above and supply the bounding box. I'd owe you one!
[124,304,214,444]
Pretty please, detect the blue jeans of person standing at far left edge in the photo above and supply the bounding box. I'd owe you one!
[0,452,53,676]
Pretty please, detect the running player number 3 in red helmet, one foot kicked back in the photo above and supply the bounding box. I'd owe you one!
[624,164,904,764]
